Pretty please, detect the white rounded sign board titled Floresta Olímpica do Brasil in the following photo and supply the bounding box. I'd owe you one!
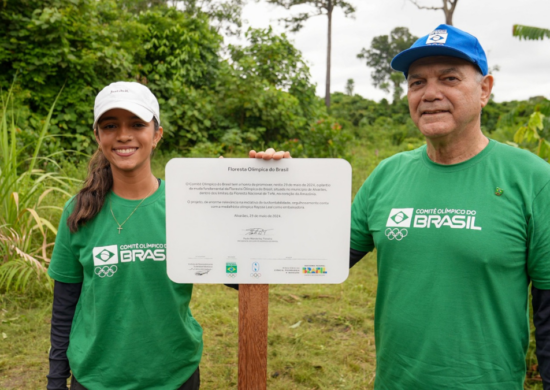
[166,158,351,284]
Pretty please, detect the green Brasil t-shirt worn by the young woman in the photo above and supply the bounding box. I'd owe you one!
[48,182,203,390]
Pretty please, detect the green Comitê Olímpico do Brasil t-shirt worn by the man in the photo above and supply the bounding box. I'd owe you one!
[351,141,550,390]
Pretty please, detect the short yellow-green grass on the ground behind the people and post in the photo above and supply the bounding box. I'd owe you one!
[0,139,542,390]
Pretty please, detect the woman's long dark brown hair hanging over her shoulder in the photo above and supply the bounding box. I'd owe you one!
[67,118,160,233]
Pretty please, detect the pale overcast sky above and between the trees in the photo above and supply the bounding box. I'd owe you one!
[229,0,550,102]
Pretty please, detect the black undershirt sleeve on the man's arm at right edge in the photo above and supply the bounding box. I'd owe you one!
[531,286,550,390]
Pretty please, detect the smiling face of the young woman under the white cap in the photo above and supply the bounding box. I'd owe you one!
[95,108,162,173]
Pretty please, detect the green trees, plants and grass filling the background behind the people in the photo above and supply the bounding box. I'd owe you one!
[0,0,550,389]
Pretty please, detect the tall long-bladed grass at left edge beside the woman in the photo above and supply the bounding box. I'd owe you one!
[0,86,75,291]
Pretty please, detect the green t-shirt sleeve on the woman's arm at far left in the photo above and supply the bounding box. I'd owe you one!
[48,198,83,283]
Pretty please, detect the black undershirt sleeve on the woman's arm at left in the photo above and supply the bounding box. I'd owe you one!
[47,281,82,390]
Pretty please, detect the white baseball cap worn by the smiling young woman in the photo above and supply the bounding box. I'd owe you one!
[93,81,160,129]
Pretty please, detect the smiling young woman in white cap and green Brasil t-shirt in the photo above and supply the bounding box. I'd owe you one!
[47,82,203,390]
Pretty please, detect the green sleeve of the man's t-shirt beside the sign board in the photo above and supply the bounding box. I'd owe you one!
[350,179,374,252]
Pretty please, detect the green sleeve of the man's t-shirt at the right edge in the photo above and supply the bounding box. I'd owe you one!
[527,182,550,290]
